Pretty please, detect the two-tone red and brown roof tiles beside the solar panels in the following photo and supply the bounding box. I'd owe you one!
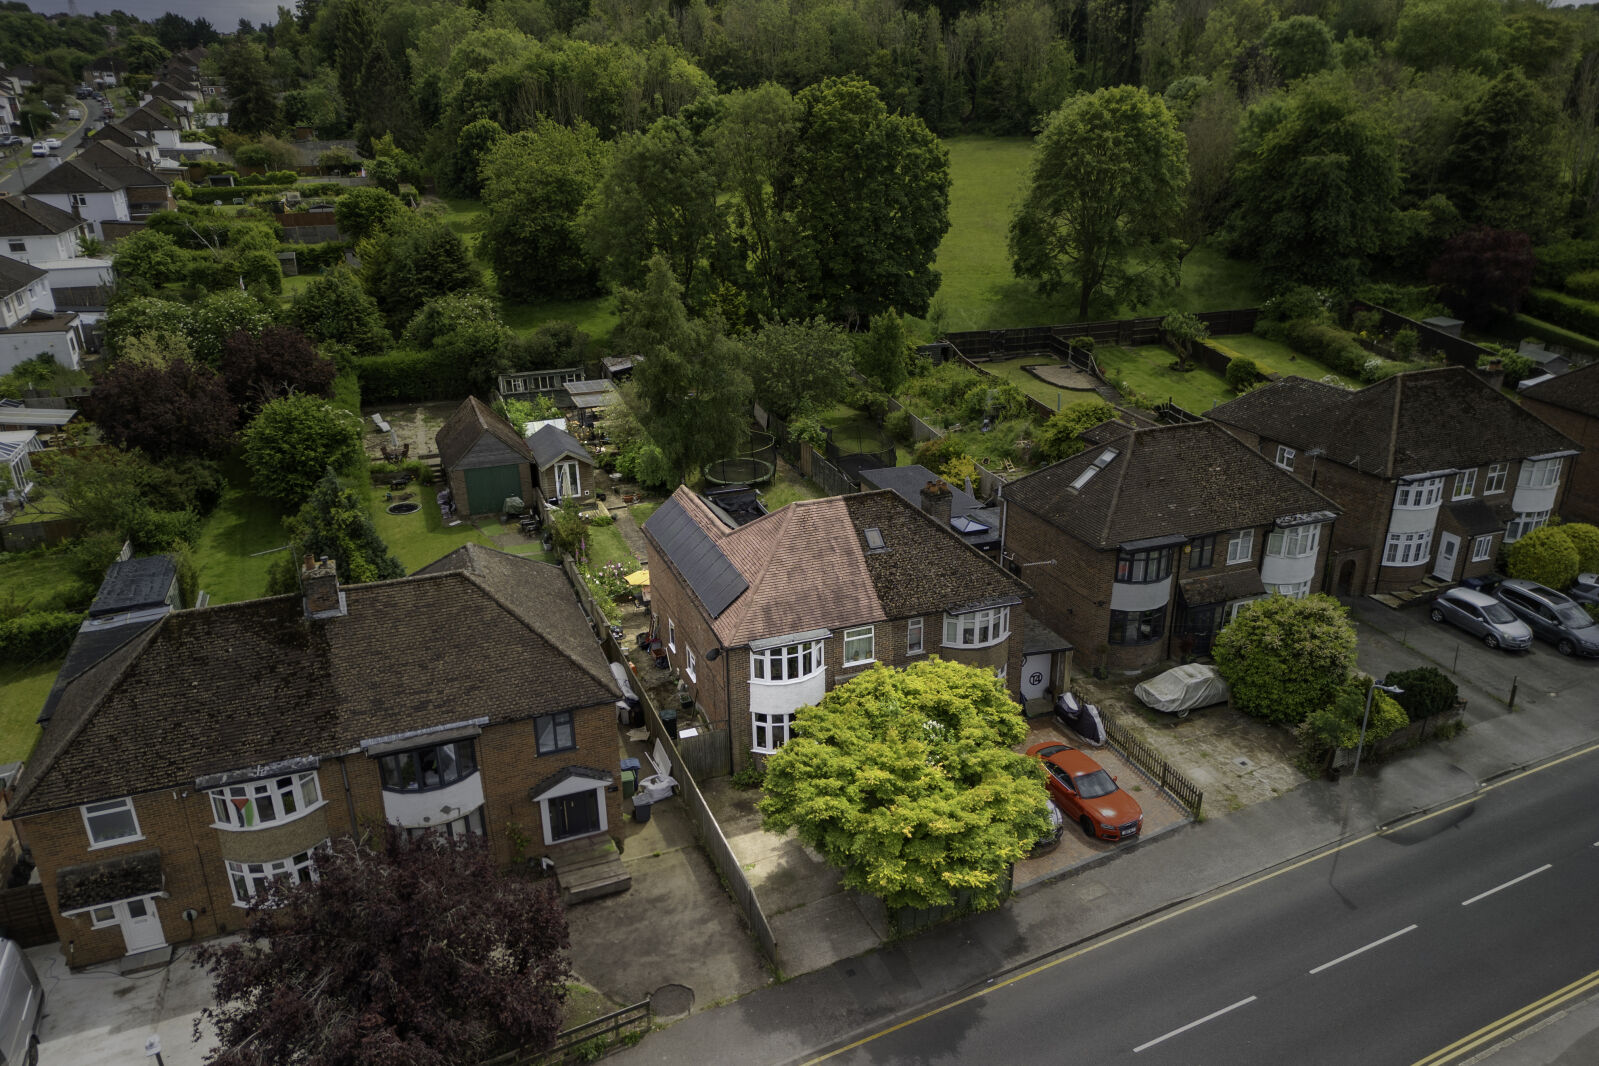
[644,487,1028,647]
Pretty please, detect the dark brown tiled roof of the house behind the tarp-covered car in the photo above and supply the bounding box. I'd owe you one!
[1004,422,1340,548]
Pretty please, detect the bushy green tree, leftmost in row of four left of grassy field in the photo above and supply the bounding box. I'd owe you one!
[481,120,609,300]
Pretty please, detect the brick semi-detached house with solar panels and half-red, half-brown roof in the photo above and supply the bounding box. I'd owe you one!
[644,481,1030,769]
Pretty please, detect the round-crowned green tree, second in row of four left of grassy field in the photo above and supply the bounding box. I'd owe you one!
[582,118,721,294]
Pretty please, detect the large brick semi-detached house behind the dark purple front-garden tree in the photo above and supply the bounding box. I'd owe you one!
[8,545,622,967]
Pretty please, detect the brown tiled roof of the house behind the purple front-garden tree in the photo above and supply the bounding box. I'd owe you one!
[11,548,620,813]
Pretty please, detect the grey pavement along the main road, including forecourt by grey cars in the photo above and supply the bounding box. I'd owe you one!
[616,603,1599,1066]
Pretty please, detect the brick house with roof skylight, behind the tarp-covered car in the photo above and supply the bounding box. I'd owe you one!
[1001,422,1338,671]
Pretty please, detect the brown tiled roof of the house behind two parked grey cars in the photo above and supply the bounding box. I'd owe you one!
[1207,366,1575,478]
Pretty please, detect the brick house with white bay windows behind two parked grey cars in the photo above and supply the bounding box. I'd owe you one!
[1209,366,1577,596]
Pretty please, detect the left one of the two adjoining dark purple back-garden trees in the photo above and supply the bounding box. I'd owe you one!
[86,358,238,459]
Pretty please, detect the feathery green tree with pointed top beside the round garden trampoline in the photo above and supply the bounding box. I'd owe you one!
[617,256,753,475]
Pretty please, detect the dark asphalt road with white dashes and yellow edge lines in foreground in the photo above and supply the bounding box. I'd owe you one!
[812,741,1599,1066]
